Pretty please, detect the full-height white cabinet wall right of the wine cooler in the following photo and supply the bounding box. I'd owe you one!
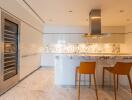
[20,23,42,78]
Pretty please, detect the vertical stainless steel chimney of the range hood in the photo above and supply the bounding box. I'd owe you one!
[89,9,101,35]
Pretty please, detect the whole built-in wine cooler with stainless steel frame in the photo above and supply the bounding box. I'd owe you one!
[0,12,19,93]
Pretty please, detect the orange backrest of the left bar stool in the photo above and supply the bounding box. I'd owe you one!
[79,62,96,74]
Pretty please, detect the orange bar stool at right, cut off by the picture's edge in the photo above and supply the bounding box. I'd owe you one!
[102,62,132,100]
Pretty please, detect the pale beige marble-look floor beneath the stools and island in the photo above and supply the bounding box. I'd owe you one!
[0,68,132,100]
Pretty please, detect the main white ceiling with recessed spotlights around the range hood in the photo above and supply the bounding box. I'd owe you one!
[17,0,132,26]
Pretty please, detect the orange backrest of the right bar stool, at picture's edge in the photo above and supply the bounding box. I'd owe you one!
[113,62,132,75]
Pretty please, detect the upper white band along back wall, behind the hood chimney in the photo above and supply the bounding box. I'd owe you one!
[44,24,125,33]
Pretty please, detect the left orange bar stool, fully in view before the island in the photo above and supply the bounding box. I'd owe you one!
[75,62,98,100]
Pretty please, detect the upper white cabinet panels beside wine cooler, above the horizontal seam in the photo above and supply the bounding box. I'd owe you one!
[20,22,43,55]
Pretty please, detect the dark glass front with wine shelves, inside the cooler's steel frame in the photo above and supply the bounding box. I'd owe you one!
[3,19,18,81]
